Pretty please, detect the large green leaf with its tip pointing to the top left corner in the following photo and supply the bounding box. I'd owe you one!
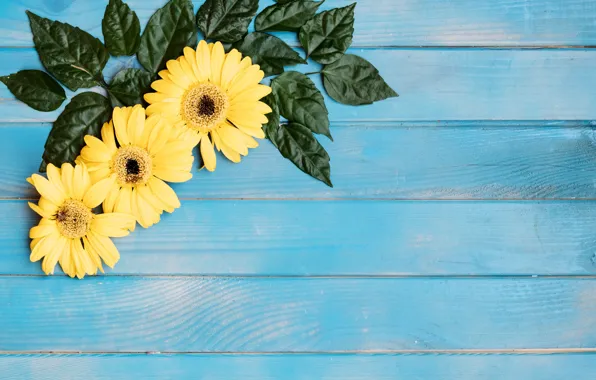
[27,11,108,91]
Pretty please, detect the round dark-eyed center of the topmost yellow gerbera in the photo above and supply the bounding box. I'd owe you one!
[180,83,229,131]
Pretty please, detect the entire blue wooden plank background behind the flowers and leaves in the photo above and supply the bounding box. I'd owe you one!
[0,0,596,380]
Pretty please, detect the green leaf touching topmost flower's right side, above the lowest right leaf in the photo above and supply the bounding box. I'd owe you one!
[271,71,332,139]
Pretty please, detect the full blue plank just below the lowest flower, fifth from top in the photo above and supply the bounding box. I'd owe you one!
[0,276,596,352]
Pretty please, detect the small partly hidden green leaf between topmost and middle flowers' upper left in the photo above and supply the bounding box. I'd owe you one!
[108,69,151,106]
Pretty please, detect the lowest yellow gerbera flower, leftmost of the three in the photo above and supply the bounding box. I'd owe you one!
[27,164,135,278]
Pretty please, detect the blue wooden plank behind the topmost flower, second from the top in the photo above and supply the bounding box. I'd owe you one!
[0,48,596,123]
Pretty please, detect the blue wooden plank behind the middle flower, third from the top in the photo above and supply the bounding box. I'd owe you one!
[0,122,596,199]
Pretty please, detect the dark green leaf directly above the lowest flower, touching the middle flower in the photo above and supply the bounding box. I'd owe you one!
[40,92,112,169]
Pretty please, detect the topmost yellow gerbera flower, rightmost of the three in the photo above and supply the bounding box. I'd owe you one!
[145,41,271,171]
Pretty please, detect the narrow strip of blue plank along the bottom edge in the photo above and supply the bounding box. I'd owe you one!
[0,354,596,380]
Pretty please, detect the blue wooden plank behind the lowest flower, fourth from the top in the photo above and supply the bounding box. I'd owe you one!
[0,197,596,276]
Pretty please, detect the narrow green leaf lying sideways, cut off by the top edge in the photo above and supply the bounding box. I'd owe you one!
[255,0,323,32]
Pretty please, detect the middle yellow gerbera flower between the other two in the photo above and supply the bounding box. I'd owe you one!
[77,105,194,228]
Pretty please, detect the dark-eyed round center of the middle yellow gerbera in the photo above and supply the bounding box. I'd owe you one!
[112,146,152,185]
